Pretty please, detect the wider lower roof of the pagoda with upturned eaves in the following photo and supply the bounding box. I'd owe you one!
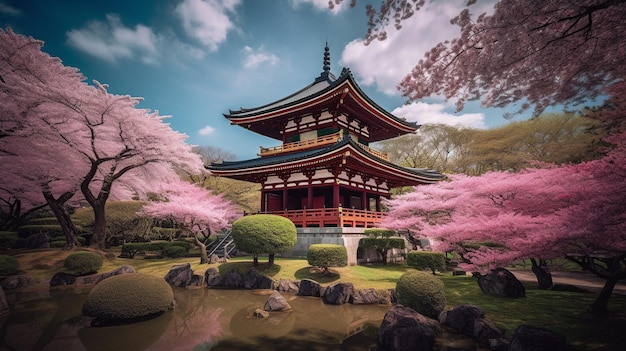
[207,137,445,186]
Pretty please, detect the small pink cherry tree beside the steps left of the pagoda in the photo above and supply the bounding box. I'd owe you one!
[140,181,241,263]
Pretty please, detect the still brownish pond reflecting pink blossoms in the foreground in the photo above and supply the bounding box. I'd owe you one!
[0,288,482,351]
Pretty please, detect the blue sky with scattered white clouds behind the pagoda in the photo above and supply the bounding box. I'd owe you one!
[0,0,520,159]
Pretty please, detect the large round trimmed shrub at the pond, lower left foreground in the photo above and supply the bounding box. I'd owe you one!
[83,273,174,323]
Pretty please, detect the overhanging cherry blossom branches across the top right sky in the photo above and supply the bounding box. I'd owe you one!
[335,0,626,115]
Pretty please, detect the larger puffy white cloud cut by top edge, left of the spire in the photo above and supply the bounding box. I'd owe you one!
[174,0,240,51]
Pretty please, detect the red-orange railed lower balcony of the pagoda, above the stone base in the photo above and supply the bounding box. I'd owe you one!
[265,207,384,228]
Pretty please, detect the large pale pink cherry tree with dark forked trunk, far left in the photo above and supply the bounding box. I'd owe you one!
[0,29,204,249]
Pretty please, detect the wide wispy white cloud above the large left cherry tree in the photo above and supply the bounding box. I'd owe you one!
[66,14,157,64]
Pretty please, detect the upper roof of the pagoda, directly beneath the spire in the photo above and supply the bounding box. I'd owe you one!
[224,67,419,142]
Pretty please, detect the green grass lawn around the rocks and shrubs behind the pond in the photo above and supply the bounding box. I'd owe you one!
[6,249,626,351]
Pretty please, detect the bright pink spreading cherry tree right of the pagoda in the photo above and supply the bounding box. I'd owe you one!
[382,133,626,312]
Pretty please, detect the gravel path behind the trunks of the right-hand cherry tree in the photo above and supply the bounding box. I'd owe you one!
[510,269,626,295]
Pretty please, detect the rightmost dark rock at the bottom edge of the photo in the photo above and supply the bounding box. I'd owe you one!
[509,325,567,351]
